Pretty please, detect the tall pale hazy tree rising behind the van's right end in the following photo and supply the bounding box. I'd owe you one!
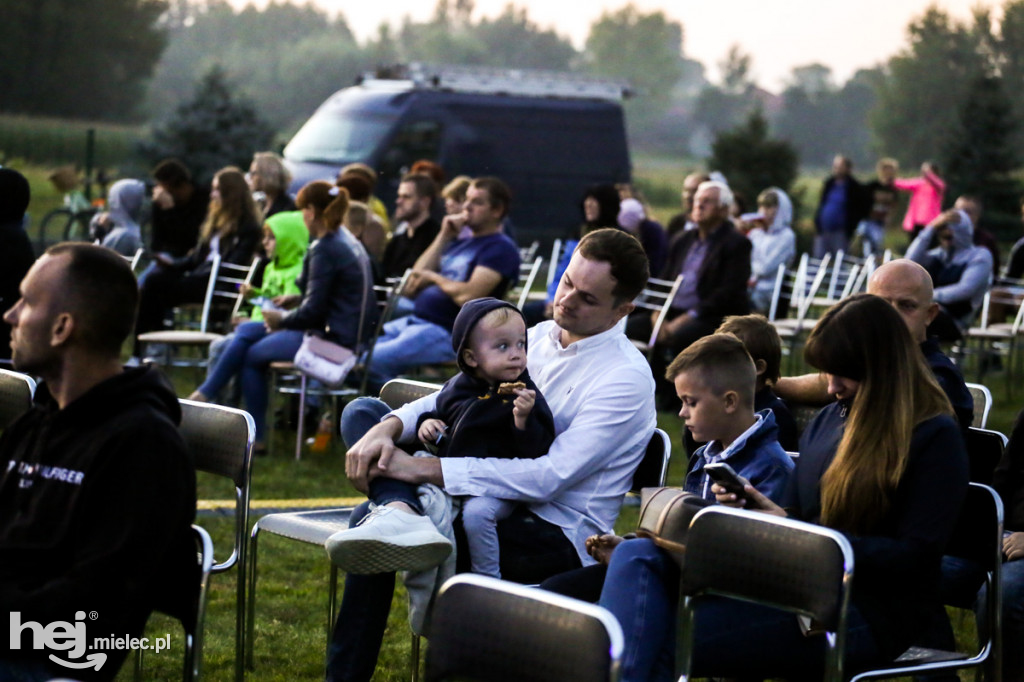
[584,4,683,131]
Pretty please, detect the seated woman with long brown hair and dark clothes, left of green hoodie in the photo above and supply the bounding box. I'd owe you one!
[135,166,263,346]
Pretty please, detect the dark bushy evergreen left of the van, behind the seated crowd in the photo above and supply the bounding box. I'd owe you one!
[141,67,273,182]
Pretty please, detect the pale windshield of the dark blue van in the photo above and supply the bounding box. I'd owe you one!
[285,110,397,164]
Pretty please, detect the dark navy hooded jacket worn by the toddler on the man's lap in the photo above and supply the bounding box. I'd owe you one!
[418,298,555,459]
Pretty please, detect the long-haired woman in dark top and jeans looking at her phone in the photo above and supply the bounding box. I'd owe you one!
[600,294,968,681]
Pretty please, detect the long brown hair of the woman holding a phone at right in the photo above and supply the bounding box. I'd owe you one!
[804,294,952,534]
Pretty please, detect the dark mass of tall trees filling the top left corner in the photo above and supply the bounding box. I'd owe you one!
[0,0,167,120]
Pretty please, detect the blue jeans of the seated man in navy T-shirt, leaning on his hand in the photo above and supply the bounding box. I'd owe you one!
[362,315,455,390]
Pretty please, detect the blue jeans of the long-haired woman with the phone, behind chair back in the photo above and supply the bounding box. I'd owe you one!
[599,539,881,682]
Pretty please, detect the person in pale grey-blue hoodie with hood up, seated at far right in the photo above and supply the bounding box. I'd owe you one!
[906,202,992,341]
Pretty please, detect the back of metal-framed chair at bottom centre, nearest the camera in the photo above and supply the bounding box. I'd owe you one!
[426,574,624,682]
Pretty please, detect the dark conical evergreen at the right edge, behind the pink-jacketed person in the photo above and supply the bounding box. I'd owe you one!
[944,76,1021,239]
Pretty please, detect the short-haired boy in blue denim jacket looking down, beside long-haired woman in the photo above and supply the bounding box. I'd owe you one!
[666,334,793,501]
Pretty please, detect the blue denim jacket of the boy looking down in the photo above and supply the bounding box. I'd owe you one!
[683,410,794,502]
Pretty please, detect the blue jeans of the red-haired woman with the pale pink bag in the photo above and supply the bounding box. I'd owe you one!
[199,322,303,441]
